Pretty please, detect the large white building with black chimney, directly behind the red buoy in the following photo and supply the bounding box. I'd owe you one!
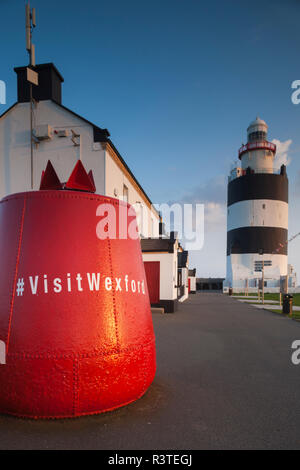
[0,63,160,237]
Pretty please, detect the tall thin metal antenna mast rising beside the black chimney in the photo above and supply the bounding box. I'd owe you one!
[25,2,38,189]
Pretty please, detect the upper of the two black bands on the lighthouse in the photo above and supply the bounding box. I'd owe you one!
[227,173,288,206]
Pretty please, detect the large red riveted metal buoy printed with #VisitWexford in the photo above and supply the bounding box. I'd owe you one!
[0,182,155,418]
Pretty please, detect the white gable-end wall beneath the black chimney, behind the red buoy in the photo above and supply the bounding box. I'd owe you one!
[0,101,105,197]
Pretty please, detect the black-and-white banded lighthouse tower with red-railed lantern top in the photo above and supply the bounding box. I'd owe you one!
[224,117,288,290]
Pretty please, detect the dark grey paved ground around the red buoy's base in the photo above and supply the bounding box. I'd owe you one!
[0,293,300,450]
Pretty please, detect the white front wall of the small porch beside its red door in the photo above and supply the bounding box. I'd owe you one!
[143,250,177,300]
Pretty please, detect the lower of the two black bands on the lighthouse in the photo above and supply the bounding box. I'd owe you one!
[227,227,288,256]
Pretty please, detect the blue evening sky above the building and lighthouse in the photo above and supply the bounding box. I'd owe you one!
[0,0,300,277]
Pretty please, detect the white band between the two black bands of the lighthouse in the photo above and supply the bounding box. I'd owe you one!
[227,199,288,230]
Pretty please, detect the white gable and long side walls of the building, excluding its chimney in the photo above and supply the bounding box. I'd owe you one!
[0,100,159,237]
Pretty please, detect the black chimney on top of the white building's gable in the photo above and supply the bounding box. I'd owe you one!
[14,63,64,104]
